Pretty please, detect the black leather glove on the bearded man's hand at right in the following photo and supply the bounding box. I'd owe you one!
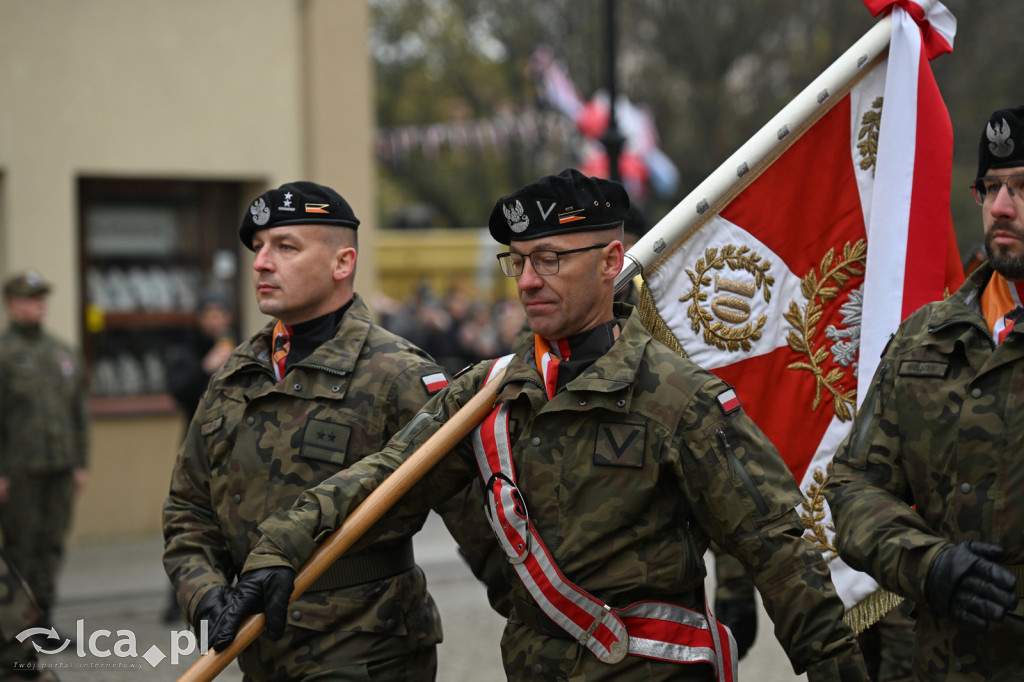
[925,540,1017,630]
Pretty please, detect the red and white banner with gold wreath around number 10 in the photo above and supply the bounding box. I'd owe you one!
[644,0,964,631]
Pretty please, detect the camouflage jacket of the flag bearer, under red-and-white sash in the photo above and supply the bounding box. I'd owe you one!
[247,305,863,680]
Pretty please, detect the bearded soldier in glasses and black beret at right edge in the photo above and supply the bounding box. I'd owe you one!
[825,106,1024,680]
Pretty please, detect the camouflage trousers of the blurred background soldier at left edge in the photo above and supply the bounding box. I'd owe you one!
[0,470,75,617]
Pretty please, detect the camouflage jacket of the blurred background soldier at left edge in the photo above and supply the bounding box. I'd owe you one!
[0,326,89,475]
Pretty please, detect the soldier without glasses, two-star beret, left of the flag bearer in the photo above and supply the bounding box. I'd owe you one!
[164,182,447,681]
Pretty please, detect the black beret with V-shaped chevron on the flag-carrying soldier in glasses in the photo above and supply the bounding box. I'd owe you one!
[487,168,630,244]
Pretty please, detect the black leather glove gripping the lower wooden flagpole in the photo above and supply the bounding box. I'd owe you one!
[210,566,295,651]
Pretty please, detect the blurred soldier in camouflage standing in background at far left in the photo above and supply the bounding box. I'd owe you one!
[0,270,89,627]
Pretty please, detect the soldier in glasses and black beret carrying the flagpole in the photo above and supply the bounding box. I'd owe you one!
[211,170,866,682]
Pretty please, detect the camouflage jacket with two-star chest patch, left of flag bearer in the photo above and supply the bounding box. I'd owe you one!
[164,296,446,664]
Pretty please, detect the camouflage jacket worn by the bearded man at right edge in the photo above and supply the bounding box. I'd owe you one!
[825,264,1024,680]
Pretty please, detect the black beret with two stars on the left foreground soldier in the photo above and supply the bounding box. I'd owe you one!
[239,180,359,251]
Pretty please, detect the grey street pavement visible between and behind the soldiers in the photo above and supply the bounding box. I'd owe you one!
[25,514,806,682]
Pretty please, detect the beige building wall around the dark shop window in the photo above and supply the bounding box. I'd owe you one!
[0,0,376,537]
